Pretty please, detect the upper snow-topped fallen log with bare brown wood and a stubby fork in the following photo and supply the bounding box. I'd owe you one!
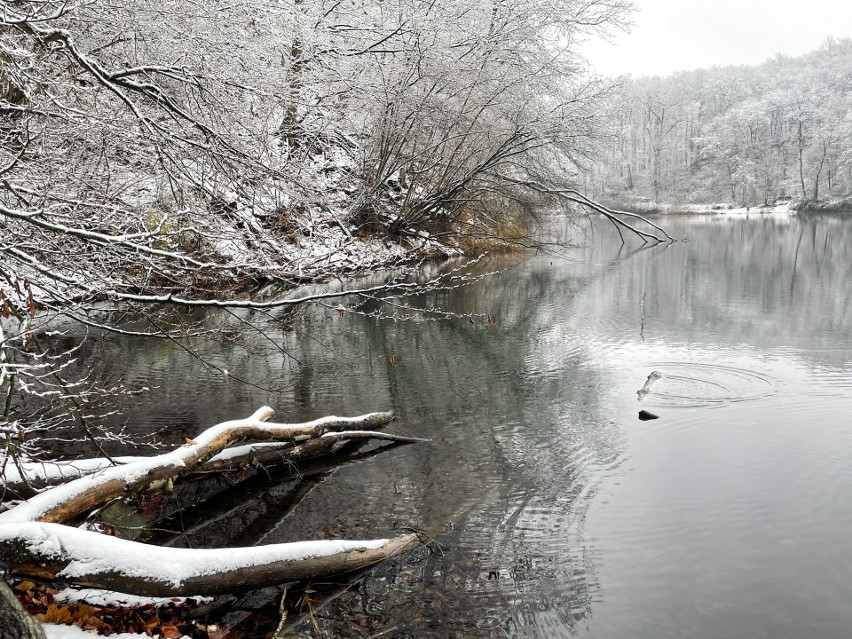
[0,406,393,524]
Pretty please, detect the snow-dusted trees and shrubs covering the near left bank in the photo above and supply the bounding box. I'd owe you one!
[0,0,631,460]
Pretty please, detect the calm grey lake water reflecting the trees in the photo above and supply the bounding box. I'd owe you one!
[83,216,852,639]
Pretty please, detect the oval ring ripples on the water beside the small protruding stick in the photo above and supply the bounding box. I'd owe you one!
[640,362,777,408]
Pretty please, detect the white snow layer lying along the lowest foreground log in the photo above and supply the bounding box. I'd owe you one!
[0,522,388,588]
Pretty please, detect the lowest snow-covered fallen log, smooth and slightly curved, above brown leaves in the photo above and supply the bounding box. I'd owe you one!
[0,522,420,597]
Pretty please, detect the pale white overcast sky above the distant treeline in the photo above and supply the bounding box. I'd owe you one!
[583,0,852,76]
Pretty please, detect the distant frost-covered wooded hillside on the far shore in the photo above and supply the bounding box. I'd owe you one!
[597,39,852,209]
